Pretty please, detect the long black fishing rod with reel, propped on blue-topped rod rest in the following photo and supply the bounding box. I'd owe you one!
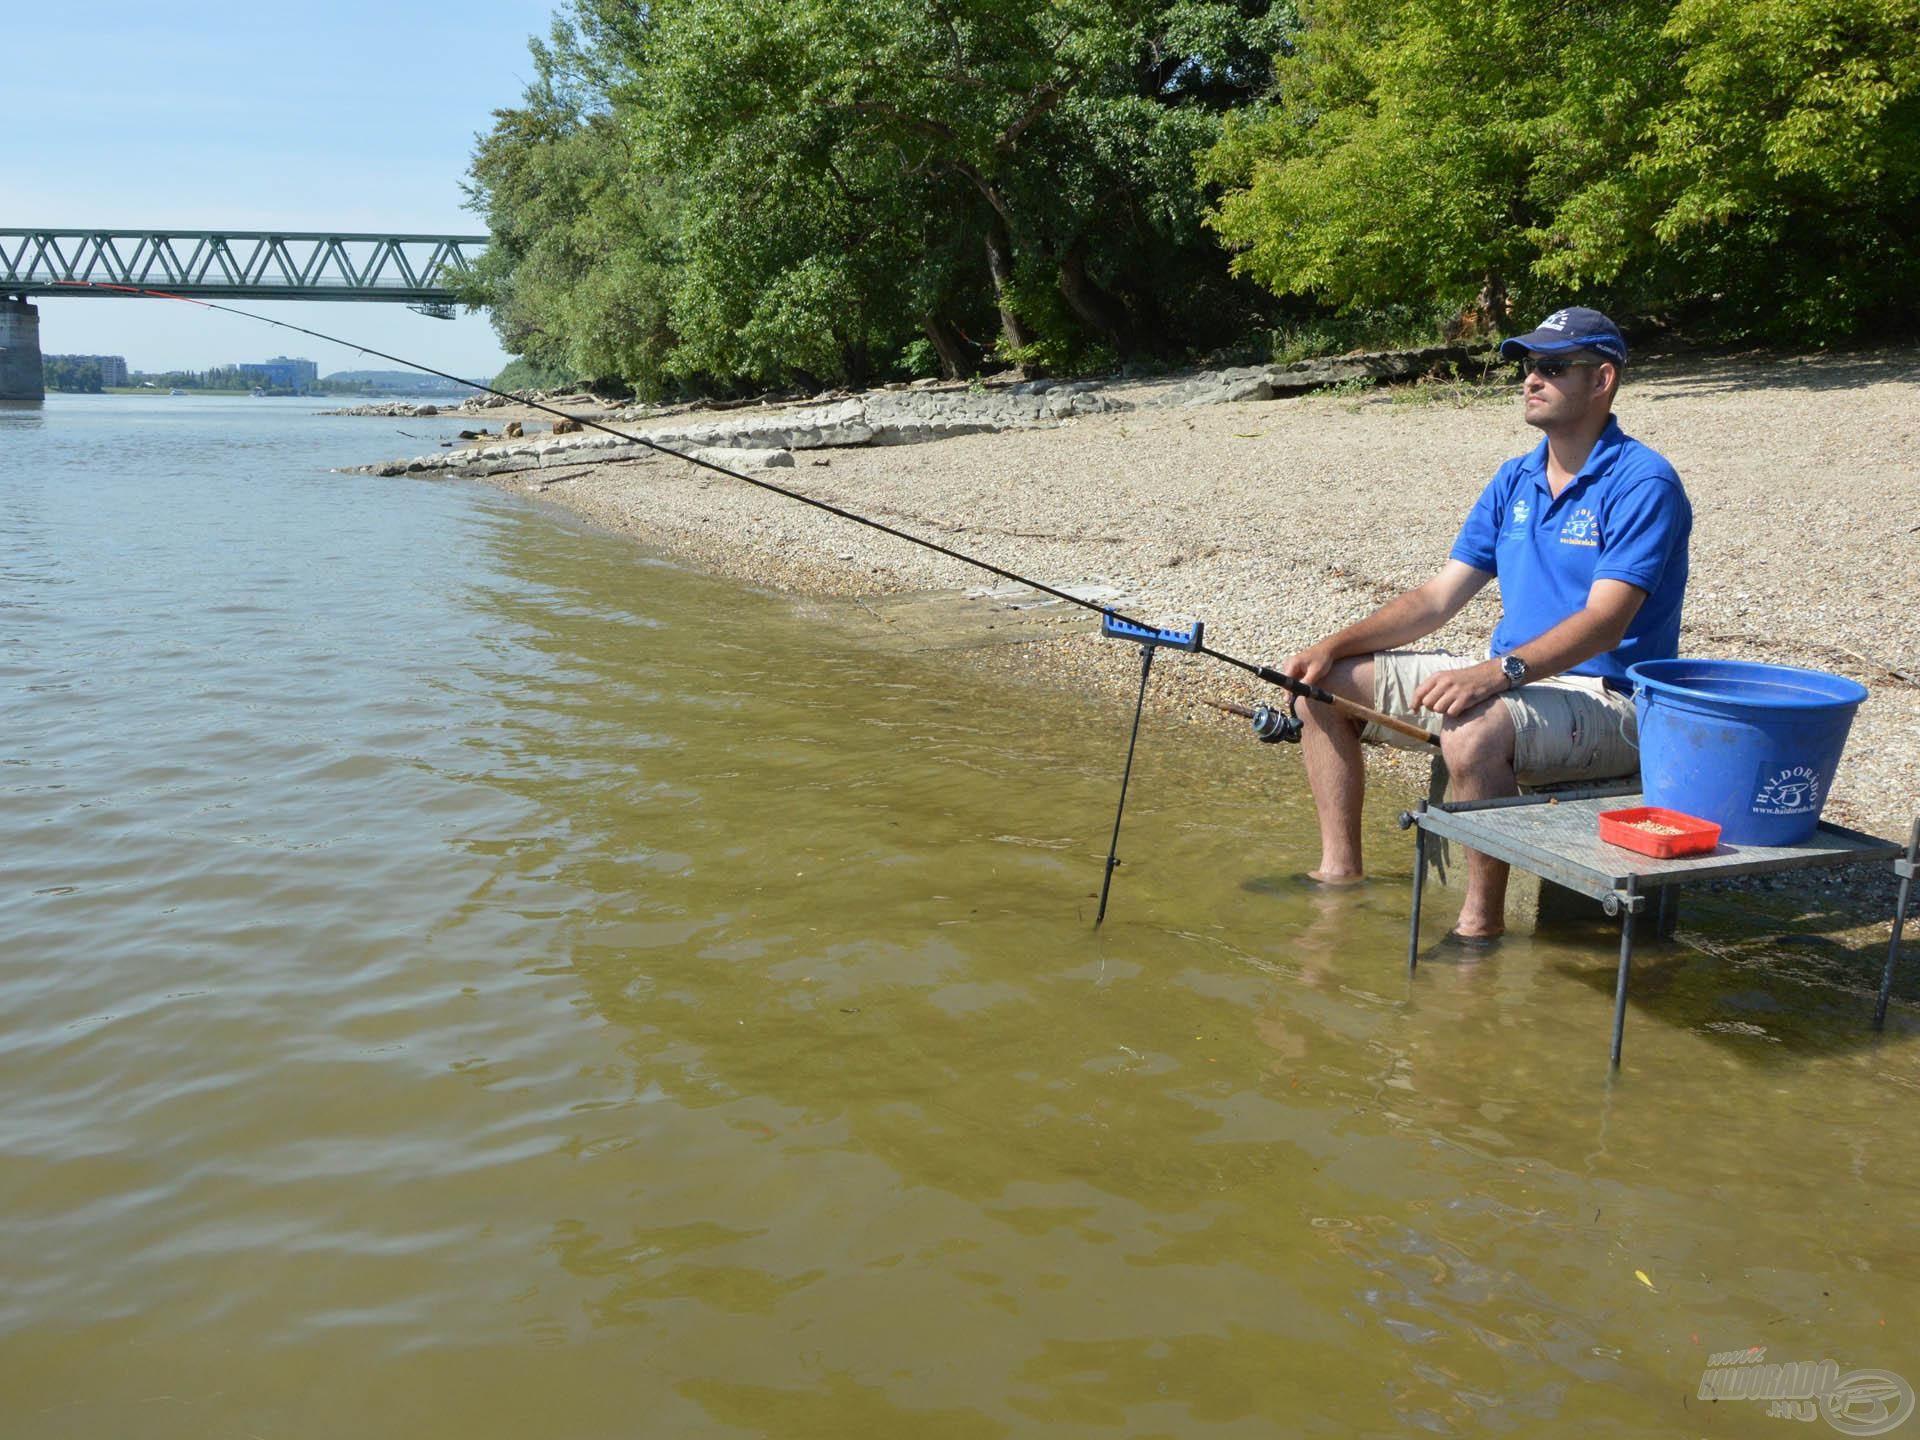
[56,280,1440,925]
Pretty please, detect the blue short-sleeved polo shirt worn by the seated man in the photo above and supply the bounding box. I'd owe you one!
[1452,419,1693,680]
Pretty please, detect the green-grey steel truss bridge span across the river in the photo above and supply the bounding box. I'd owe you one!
[0,230,488,317]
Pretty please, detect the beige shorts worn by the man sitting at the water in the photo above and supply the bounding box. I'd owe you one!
[1359,651,1640,785]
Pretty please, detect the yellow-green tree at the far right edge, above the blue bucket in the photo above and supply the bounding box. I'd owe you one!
[1634,0,1920,338]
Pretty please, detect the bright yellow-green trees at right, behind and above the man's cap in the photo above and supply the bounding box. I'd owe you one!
[1202,0,1920,338]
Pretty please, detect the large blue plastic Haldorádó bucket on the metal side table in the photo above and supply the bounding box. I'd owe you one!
[1626,660,1866,845]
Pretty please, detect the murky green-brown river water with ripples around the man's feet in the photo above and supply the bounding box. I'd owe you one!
[0,397,1920,1440]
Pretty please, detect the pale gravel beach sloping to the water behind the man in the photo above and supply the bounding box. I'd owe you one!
[424,349,1920,867]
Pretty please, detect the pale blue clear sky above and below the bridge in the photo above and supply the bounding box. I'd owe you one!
[0,0,555,376]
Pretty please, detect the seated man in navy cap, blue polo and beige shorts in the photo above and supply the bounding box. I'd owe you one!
[1281,307,1693,948]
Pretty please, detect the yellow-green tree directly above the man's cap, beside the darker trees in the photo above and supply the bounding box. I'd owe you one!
[1202,0,1668,324]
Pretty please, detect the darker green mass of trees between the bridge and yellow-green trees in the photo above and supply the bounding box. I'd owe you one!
[470,0,1290,395]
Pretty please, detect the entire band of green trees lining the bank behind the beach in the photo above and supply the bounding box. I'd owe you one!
[468,0,1920,392]
